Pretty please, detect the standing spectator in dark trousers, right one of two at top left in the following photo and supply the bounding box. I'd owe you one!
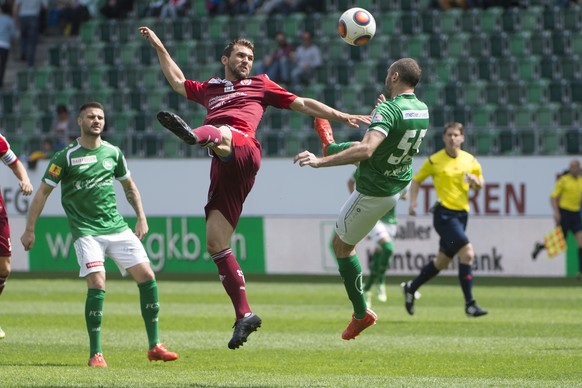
[12,0,48,67]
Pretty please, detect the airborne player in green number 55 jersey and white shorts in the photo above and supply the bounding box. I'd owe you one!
[294,58,428,340]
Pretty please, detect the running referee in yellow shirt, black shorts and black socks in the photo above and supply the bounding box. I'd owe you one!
[401,122,487,317]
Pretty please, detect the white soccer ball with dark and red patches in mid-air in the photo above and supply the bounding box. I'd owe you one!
[337,7,376,46]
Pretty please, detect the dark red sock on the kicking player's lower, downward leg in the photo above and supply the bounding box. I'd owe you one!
[212,248,251,320]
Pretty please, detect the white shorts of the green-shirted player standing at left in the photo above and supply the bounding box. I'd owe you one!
[73,229,150,278]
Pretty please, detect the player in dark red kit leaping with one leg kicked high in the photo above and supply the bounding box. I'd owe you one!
[139,27,370,349]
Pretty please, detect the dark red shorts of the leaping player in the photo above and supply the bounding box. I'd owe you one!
[204,129,261,228]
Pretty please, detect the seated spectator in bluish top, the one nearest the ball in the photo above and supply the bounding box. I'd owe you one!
[291,31,322,86]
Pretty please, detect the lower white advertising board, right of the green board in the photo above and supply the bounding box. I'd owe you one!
[265,217,566,277]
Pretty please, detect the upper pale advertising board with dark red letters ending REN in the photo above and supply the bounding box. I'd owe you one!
[0,156,572,217]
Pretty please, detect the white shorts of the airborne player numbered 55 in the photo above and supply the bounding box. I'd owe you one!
[335,188,408,245]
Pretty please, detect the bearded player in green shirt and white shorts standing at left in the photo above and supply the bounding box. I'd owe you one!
[20,102,178,367]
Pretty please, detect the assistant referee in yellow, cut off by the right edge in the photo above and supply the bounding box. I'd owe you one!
[532,159,582,279]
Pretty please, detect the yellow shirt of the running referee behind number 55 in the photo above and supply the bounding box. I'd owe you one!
[413,149,483,211]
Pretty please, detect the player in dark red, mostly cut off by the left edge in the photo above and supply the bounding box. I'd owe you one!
[0,135,32,339]
